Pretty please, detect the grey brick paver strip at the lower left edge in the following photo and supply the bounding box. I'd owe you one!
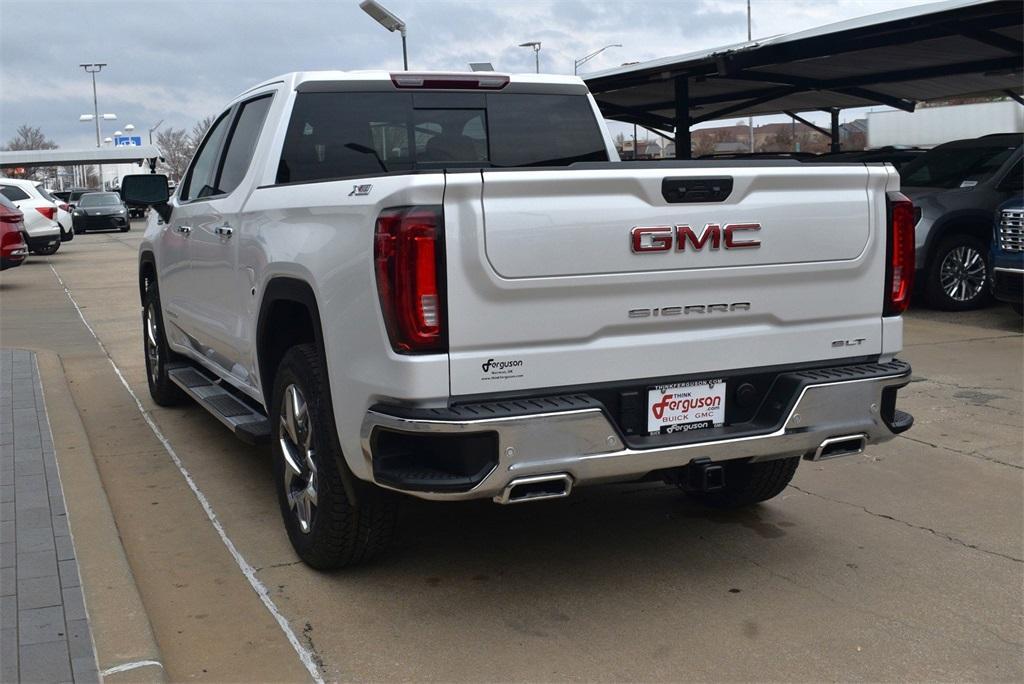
[0,349,99,684]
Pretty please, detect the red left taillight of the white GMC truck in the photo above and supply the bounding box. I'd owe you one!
[374,207,446,353]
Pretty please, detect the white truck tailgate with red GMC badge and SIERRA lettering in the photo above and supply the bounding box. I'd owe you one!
[444,164,898,395]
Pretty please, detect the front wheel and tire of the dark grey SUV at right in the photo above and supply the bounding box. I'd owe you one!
[925,234,989,311]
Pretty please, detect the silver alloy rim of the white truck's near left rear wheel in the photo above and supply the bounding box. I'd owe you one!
[278,385,317,535]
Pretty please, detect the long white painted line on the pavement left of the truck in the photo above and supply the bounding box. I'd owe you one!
[50,264,324,684]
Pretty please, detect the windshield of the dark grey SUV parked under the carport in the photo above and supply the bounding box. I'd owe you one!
[900,145,1017,187]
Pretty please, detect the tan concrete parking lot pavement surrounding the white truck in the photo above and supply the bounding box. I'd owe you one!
[0,222,1024,681]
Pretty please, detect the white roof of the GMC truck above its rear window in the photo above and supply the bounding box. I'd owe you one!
[239,69,589,97]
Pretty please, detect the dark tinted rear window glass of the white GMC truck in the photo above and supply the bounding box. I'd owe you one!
[278,92,608,183]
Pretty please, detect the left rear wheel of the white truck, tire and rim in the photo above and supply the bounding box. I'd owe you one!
[270,344,397,570]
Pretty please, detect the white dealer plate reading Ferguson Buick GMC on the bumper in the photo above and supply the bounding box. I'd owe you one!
[647,380,725,434]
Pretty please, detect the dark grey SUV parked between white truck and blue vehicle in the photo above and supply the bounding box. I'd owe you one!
[900,133,1024,310]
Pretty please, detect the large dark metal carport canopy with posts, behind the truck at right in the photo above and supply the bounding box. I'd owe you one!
[584,0,1024,158]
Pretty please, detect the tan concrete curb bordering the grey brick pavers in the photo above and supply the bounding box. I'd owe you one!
[36,349,167,682]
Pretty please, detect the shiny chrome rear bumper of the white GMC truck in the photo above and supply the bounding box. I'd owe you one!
[362,361,910,503]
